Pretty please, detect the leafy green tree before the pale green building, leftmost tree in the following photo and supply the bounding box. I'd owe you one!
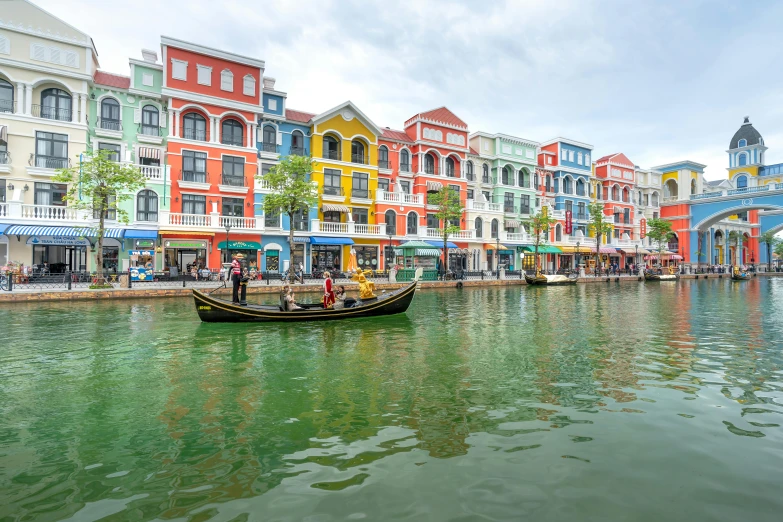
[52,150,146,286]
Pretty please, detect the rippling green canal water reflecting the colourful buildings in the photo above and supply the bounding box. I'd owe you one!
[0,278,783,522]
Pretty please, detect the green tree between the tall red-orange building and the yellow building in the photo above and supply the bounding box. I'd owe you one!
[256,155,318,281]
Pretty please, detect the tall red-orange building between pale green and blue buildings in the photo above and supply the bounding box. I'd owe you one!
[160,37,264,271]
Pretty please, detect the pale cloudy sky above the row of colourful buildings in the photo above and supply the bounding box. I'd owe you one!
[34,0,783,179]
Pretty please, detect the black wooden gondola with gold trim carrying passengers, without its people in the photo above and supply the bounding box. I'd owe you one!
[193,281,417,323]
